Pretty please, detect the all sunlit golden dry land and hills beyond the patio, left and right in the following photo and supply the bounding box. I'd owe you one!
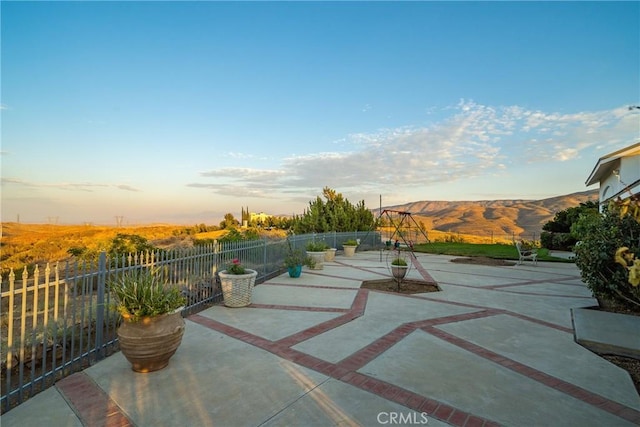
[0,190,597,274]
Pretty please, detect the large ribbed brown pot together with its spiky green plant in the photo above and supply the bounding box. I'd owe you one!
[108,268,186,372]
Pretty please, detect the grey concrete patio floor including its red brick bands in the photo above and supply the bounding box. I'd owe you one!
[1,252,640,427]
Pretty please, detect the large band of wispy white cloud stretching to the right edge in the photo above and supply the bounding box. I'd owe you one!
[188,100,640,203]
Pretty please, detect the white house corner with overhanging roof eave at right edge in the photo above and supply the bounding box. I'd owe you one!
[586,142,640,206]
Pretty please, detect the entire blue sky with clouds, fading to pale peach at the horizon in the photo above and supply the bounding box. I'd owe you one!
[0,1,640,224]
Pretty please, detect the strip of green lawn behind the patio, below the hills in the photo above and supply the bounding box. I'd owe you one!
[414,242,572,262]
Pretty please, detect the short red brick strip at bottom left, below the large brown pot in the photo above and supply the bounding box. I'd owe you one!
[55,372,134,427]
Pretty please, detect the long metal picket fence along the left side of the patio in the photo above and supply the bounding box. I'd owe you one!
[0,231,381,413]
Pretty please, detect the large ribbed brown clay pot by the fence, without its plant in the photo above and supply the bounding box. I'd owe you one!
[118,311,184,372]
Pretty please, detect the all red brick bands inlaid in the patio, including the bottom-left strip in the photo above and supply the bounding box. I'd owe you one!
[56,254,640,427]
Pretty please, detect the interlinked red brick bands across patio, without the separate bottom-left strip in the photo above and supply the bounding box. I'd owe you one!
[189,259,640,427]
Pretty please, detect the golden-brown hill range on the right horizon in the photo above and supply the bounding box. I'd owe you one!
[373,189,598,236]
